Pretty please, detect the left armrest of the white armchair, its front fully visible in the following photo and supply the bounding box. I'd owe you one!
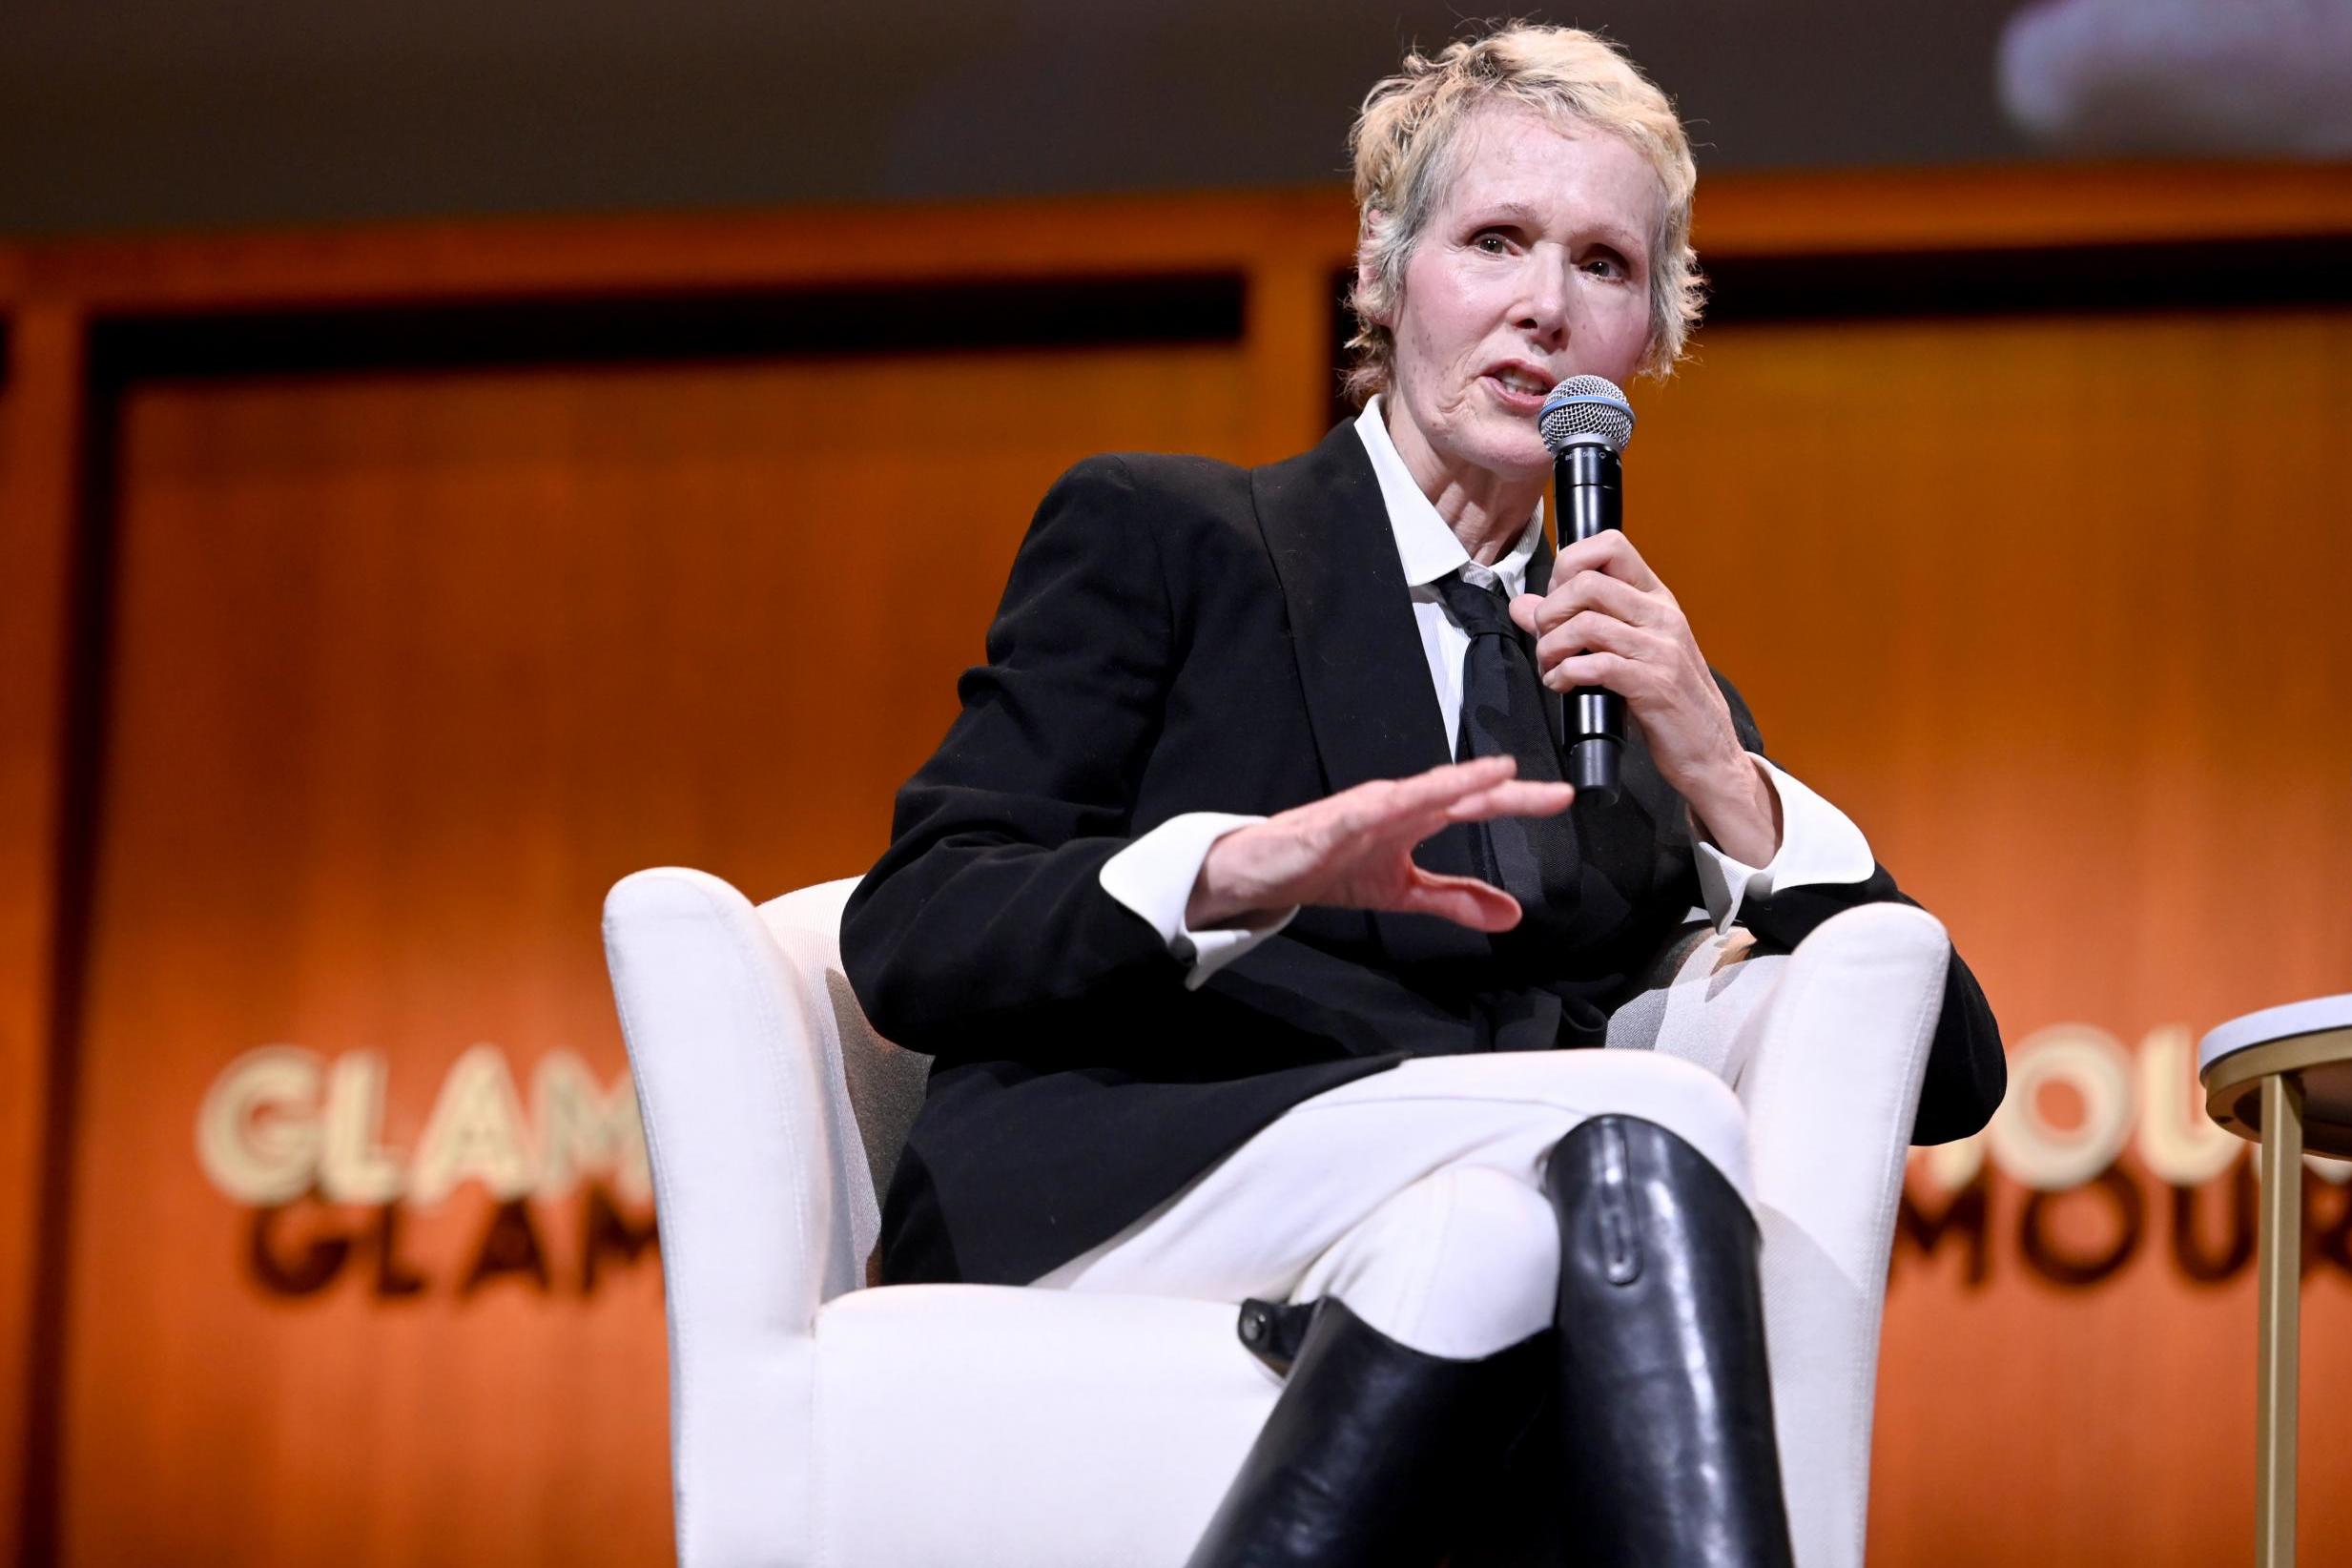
[605,870,865,1568]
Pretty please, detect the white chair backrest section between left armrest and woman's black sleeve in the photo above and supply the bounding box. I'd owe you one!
[760,877,932,1248]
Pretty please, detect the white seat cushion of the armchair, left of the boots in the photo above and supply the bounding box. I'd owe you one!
[814,1286,1282,1568]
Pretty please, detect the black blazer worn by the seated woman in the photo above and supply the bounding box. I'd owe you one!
[842,413,2006,1284]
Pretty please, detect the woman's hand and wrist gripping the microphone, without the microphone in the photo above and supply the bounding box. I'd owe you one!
[1510,529,1781,865]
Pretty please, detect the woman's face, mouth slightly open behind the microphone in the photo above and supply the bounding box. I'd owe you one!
[1388,106,1665,480]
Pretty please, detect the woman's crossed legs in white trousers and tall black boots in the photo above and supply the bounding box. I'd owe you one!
[1035,1051,1785,1568]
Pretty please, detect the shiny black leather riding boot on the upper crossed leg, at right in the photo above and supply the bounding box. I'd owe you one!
[1543,1117,1790,1568]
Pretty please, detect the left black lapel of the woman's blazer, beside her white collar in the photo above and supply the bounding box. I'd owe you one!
[1251,421,1487,964]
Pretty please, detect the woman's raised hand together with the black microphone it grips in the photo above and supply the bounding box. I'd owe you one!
[1510,376,1778,865]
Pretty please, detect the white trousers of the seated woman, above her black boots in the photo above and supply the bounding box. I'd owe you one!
[1035,1051,1755,1359]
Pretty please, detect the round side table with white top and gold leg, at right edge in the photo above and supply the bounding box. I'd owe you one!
[2197,995,2352,1568]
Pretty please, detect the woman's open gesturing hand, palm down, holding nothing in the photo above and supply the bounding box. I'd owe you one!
[1186,757,1576,931]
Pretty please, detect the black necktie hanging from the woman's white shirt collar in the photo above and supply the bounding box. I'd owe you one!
[1437,571,1580,936]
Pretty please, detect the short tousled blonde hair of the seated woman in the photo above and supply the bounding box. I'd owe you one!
[1348,24,1705,404]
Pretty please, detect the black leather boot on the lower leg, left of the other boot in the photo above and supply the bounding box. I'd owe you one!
[1187,1295,1553,1568]
